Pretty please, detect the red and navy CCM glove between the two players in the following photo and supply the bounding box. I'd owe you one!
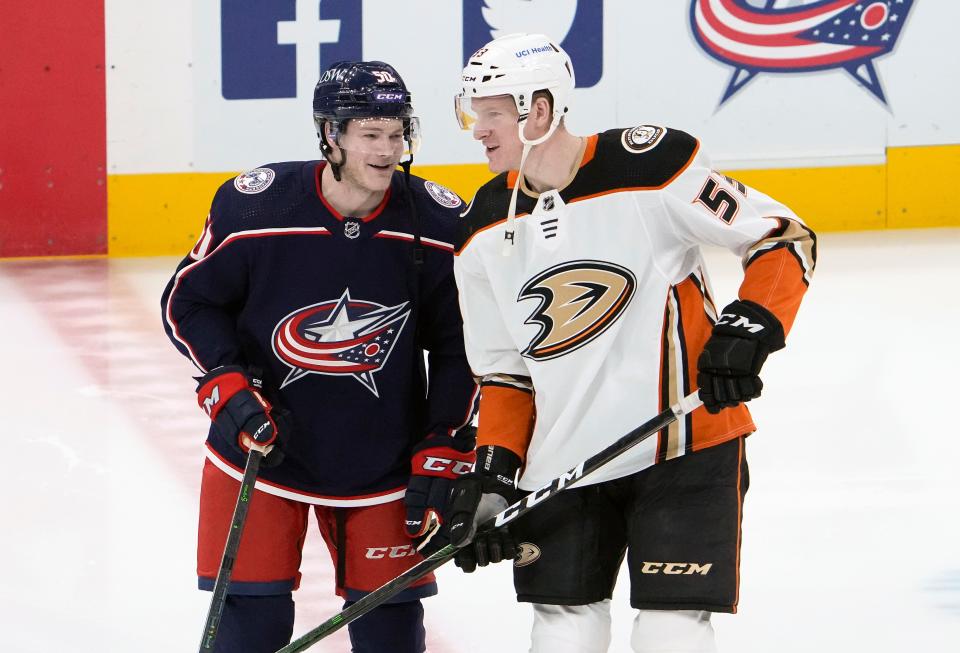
[403,428,477,555]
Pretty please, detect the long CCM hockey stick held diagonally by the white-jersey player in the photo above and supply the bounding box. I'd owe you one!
[276,392,703,653]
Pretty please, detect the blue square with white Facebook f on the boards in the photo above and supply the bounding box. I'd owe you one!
[220,0,363,100]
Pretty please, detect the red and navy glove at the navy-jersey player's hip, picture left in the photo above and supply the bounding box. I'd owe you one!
[197,365,289,467]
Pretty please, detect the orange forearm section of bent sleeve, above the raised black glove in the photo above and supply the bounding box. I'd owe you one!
[740,248,807,334]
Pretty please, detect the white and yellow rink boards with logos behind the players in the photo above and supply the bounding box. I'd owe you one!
[1,0,960,255]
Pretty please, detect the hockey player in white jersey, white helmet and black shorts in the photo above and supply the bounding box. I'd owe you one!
[450,34,816,653]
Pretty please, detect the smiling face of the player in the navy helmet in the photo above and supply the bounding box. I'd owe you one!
[331,118,406,193]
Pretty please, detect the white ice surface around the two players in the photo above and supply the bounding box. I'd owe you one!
[0,229,960,653]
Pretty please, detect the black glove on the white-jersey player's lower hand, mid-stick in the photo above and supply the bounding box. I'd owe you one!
[449,446,522,574]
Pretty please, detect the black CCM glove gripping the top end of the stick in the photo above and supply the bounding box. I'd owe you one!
[697,300,784,413]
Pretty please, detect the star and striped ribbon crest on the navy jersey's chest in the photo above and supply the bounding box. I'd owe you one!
[272,289,410,397]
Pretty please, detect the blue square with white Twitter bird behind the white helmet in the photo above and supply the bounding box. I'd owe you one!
[463,0,603,88]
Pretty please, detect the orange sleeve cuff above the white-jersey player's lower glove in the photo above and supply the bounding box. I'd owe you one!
[477,385,534,460]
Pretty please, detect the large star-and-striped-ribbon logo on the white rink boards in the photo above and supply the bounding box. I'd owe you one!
[690,0,913,105]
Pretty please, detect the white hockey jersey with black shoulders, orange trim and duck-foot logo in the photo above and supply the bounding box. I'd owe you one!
[454,125,816,490]
